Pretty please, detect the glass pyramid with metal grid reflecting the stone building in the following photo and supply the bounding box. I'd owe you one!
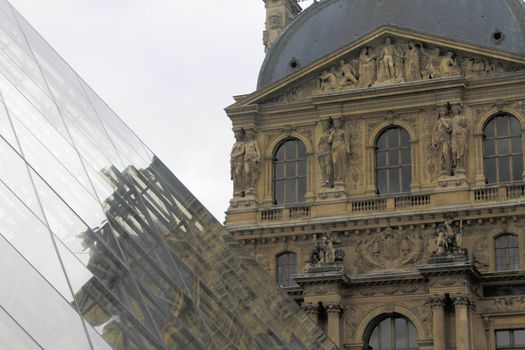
[0,0,335,350]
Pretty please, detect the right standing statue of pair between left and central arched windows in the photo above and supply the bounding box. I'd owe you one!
[328,118,350,186]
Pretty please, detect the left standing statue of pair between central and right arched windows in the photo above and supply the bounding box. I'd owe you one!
[432,106,452,176]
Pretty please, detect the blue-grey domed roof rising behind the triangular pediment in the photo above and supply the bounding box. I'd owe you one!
[258,0,525,88]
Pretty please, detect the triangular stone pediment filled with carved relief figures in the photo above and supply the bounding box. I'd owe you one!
[234,28,525,104]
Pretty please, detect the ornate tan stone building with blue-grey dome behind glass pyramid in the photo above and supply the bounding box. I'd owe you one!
[226,0,525,350]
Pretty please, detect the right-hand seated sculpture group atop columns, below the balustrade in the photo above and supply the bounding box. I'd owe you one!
[432,216,467,257]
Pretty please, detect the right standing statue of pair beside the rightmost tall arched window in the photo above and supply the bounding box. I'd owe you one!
[451,105,468,174]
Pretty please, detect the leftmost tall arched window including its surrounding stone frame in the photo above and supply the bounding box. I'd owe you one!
[271,137,309,205]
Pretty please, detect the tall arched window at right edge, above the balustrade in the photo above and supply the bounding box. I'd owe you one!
[483,114,523,184]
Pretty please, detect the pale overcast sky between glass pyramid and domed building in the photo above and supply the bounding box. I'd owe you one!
[11,0,312,222]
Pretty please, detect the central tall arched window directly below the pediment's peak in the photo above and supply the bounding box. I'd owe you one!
[376,127,412,194]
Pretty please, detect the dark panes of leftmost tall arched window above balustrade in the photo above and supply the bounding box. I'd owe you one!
[273,139,306,204]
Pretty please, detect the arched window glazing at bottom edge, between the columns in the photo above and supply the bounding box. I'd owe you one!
[368,316,419,350]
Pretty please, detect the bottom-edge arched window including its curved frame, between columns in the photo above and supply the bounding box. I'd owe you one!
[366,313,419,350]
